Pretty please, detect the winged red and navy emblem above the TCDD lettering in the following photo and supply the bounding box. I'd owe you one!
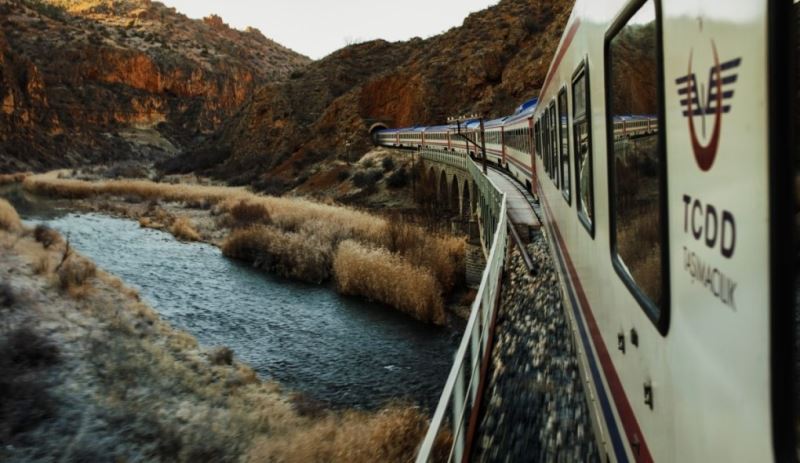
[675,40,742,172]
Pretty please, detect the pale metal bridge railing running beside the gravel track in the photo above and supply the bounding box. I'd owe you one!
[417,162,508,463]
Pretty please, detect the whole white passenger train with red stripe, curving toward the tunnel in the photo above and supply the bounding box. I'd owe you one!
[376,0,798,462]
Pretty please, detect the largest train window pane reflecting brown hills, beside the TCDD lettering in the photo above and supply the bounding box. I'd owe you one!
[606,0,669,332]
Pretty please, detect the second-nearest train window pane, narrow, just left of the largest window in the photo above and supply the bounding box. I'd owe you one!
[572,63,594,237]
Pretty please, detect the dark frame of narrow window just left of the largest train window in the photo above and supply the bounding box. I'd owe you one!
[570,56,597,239]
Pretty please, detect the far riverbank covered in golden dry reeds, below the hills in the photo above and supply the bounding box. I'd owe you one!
[18,171,466,325]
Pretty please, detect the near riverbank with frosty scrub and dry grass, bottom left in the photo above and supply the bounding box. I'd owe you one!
[0,201,444,462]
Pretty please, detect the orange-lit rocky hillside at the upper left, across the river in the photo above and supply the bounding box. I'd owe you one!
[0,0,310,172]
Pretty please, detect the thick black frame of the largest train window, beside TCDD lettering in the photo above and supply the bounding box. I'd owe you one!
[603,0,672,337]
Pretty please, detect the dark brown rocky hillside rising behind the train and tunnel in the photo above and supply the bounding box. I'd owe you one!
[174,0,572,192]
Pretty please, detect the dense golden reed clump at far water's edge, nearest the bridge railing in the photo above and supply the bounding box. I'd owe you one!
[333,240,445,325]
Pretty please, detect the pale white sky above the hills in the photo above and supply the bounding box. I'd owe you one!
[161,0,498,59]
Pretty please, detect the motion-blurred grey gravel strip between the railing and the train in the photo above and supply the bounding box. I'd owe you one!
[475,238,599,462]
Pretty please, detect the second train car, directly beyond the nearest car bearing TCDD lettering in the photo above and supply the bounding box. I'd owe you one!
[503,98,538,190]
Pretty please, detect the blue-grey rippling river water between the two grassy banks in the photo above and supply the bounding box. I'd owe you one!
[0,190,460,410]
